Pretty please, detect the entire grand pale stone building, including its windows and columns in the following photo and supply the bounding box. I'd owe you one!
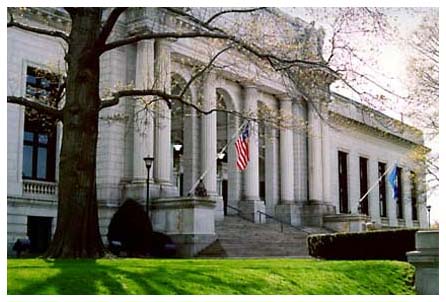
[7,8,427,255]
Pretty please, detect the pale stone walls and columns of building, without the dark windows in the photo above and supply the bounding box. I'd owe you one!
[7,8,427,254]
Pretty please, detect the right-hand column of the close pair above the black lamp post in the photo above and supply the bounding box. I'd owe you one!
[154,40,172,184]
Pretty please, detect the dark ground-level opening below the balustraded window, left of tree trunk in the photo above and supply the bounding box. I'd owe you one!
[28,216,53,254]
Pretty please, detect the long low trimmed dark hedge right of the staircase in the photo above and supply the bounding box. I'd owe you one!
[307,229,418,261]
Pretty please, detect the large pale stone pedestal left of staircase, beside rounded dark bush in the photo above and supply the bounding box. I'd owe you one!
[151,196,216,257]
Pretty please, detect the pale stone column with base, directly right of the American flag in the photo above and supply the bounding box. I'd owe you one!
[239,85,266,223]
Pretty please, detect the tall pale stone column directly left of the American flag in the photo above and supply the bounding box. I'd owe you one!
[201,73,217,195]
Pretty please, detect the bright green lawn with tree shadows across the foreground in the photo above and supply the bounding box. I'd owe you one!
[8,259,415,295]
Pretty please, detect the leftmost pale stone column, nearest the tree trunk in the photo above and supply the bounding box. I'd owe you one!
[132,41,154,182]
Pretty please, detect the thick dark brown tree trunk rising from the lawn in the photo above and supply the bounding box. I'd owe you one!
[46,8,104,258]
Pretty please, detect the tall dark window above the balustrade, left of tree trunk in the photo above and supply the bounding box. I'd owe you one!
[22,66,59,181]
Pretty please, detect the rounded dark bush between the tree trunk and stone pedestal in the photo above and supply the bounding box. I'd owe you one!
[107,199,152,257]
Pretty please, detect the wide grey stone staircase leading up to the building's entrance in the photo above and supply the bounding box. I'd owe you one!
[197,216,327,257]
